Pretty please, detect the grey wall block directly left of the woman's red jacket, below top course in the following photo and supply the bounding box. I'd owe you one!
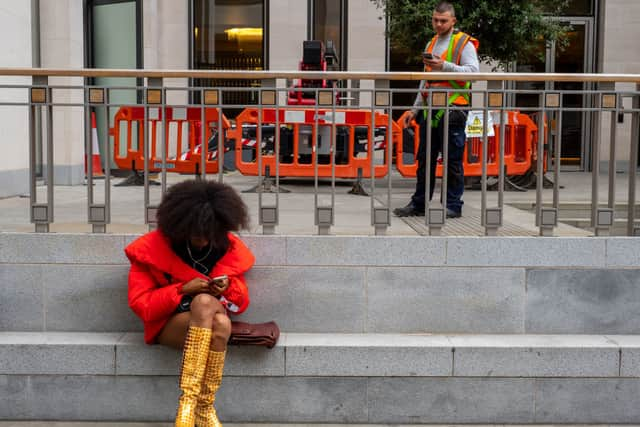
[43,265,142,332]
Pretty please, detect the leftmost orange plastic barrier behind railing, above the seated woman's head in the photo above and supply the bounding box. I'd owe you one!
[109,107,231,174]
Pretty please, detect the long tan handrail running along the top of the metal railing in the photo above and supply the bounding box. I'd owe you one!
[0,67,640,84]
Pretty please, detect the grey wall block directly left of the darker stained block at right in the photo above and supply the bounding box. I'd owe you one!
[367,267,525,333]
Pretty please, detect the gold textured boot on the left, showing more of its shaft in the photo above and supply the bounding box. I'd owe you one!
[176,326,213,427]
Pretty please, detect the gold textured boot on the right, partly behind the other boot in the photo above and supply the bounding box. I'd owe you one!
[196,351,226,427]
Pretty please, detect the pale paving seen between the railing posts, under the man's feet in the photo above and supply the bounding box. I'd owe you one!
[0,170,640,236]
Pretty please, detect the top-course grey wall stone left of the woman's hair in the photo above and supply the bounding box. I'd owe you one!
[0,233,129,264]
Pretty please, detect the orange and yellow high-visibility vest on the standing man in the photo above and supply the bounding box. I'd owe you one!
[422,31,480,105]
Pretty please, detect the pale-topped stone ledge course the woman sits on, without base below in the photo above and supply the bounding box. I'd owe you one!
[0,332,640,378]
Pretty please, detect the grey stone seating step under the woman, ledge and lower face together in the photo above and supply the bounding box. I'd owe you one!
[0,332,640,424]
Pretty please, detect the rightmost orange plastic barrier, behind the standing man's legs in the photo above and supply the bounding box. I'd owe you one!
[396,111,547,177]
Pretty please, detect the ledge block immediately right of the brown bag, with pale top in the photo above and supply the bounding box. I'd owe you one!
[286,334,453,377]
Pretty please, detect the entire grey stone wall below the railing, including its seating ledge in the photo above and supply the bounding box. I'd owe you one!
[0,233,640,425]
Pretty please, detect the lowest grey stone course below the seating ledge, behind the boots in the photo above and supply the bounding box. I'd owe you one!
[0,375,640,425]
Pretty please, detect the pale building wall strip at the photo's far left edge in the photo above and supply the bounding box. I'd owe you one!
[0,0,32,197]
